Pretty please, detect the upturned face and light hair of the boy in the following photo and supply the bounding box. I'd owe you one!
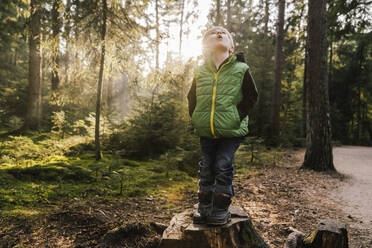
[204,28,233,53]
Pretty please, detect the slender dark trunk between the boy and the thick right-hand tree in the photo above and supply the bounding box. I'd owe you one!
[271,0,285,136]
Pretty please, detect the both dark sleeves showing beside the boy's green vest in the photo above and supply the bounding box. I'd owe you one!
[187,65,258,121]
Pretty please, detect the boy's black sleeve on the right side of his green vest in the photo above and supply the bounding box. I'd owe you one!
[237,68,258,121]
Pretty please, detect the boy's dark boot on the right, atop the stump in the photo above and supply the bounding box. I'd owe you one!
[206,193,231,225]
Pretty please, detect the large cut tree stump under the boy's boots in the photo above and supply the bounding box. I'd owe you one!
[160,204,269,248]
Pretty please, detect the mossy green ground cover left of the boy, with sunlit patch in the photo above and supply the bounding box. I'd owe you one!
[0,134,197,215]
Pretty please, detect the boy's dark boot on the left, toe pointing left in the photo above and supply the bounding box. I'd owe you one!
[193,191,213,224]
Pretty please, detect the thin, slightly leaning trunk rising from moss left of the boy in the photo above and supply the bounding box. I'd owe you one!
[95,0,107,160]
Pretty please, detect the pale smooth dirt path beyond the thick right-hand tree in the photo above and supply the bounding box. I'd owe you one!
[333,146,372,229]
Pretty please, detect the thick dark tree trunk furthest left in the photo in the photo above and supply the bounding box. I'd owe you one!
[25,0,41,130]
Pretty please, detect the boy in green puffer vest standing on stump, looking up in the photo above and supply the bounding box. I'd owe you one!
[187,27,258,225]
